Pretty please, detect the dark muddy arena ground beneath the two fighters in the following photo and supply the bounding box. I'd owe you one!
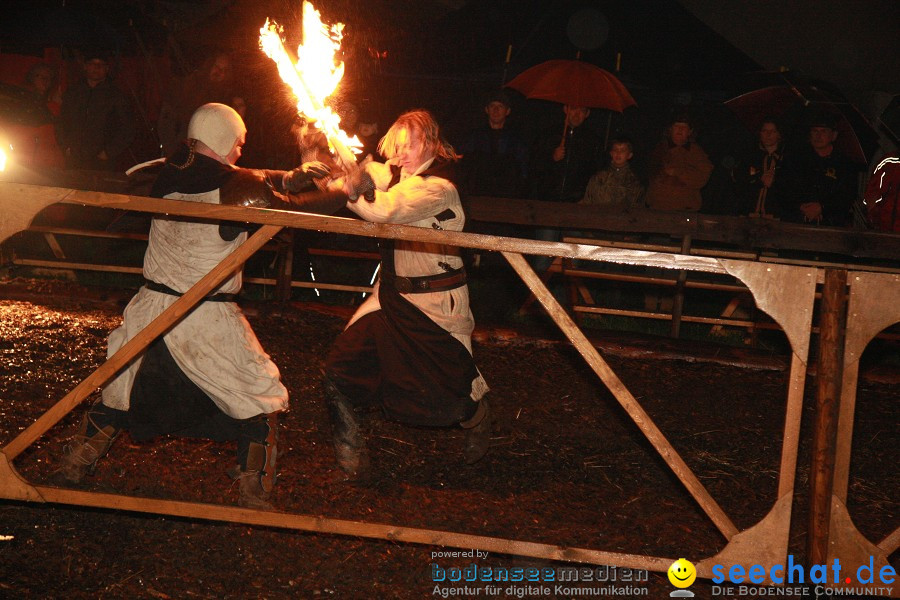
[0,286,900,599]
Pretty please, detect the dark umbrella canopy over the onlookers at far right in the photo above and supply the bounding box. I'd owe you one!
[725,76,878,164]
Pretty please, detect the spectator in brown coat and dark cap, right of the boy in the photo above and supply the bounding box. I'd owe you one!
[646,111,713,211]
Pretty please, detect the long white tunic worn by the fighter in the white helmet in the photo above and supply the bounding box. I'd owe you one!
[103,190,288,419]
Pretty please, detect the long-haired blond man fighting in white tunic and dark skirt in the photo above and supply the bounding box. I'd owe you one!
[324,110,490,480]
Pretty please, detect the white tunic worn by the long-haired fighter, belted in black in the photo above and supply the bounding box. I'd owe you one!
[347,159,488,400]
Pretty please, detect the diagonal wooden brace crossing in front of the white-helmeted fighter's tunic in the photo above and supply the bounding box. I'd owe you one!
[3,225,282,460]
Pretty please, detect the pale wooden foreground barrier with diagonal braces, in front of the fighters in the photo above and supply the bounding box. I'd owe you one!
[0,183,900,593]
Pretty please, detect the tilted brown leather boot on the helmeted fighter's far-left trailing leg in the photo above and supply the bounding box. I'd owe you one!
[51,403,122,485]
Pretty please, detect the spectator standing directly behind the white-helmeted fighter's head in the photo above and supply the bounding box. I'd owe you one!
[157,51,247,156]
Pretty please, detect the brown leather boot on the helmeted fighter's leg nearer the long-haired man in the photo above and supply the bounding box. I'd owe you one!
[237,413,278,510]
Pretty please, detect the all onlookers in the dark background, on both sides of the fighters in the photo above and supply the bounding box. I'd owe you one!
[1,51,900,234]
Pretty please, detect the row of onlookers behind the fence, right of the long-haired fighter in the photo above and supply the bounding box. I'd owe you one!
[458,92,900,231]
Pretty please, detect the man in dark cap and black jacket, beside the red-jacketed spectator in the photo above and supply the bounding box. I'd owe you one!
[783,112,858,227]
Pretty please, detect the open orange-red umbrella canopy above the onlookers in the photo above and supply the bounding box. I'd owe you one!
[506,60,637,112]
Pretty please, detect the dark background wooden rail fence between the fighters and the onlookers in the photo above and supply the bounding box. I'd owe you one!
[8,196,900,341]
